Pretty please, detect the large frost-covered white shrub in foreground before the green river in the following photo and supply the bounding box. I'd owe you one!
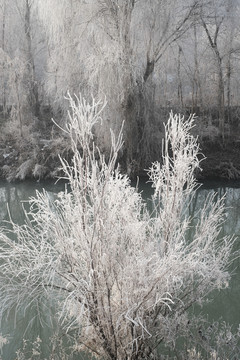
[0,96,235,360]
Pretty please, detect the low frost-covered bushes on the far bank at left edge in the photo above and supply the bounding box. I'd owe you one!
[0,116,70,182]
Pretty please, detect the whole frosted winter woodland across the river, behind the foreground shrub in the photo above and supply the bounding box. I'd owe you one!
[0,0,240,180]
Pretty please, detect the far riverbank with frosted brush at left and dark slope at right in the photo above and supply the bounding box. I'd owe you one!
[0,112,240,182]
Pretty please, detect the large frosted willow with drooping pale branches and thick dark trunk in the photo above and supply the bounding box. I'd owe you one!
[38,0,197,173]
